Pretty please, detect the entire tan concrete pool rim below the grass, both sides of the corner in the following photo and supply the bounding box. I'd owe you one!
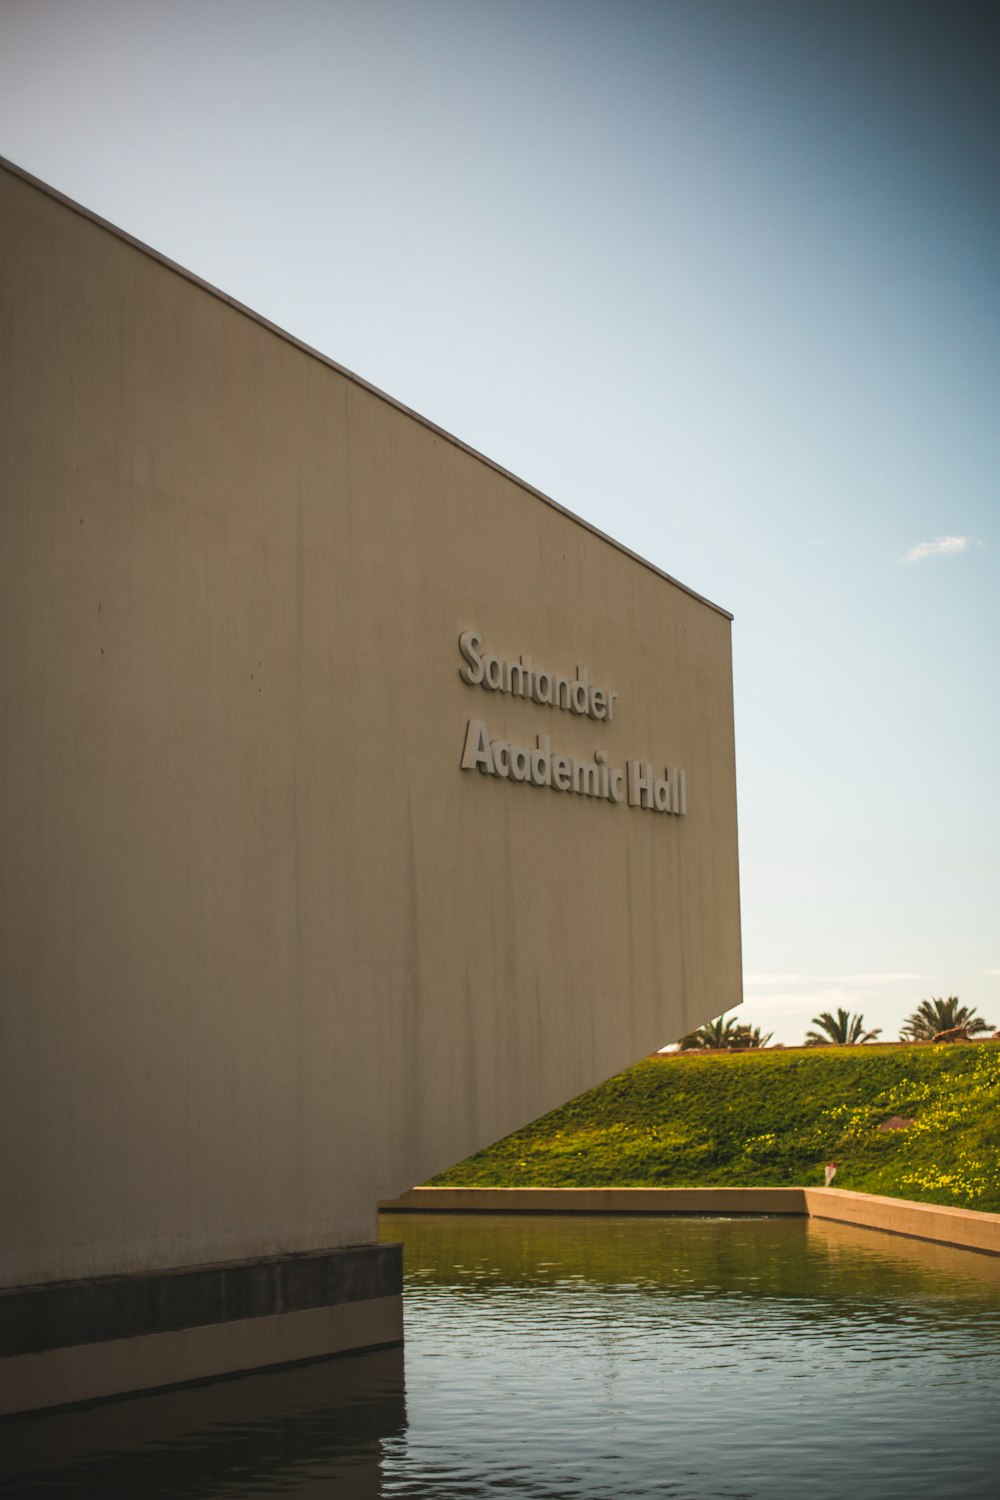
[379,1188,1000,1256]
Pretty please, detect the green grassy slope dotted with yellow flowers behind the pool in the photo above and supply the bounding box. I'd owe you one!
[432,1043,1000,1212]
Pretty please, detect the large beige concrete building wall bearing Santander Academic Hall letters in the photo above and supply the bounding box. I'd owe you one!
[0,171,741,1283]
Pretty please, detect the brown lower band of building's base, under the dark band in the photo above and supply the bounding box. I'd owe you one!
[0,1295,403,1416]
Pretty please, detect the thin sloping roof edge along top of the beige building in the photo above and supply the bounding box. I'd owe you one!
[0,156,733,620]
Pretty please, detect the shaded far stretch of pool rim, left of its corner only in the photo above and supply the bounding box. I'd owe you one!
[379,1188,808,1215]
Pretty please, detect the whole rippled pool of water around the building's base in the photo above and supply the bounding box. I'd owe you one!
[0,1214,1000,1500]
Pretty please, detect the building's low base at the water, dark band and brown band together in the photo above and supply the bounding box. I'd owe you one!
[0,1245,403,1415]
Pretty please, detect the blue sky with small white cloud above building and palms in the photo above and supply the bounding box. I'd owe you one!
[0,0,1000,1041]
